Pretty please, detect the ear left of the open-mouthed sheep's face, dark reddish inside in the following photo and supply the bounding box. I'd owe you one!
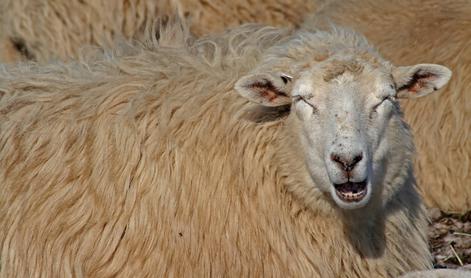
[235,73,292,107]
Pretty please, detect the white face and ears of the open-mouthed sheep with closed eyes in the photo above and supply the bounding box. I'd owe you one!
[235,57,451,209]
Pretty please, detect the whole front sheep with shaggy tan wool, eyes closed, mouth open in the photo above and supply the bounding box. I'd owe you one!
[0,24,451,277]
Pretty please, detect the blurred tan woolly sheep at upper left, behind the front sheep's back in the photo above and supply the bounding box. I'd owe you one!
[0,0,321,62]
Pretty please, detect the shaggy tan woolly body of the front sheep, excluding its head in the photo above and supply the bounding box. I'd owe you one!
[0,22,431,277]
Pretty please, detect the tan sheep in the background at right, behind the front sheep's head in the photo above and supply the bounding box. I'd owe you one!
[304,0,471,213]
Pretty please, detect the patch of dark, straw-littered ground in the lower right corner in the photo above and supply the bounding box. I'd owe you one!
[429,208,471,271]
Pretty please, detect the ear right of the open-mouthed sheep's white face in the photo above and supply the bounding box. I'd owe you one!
[392,64,451,98]
